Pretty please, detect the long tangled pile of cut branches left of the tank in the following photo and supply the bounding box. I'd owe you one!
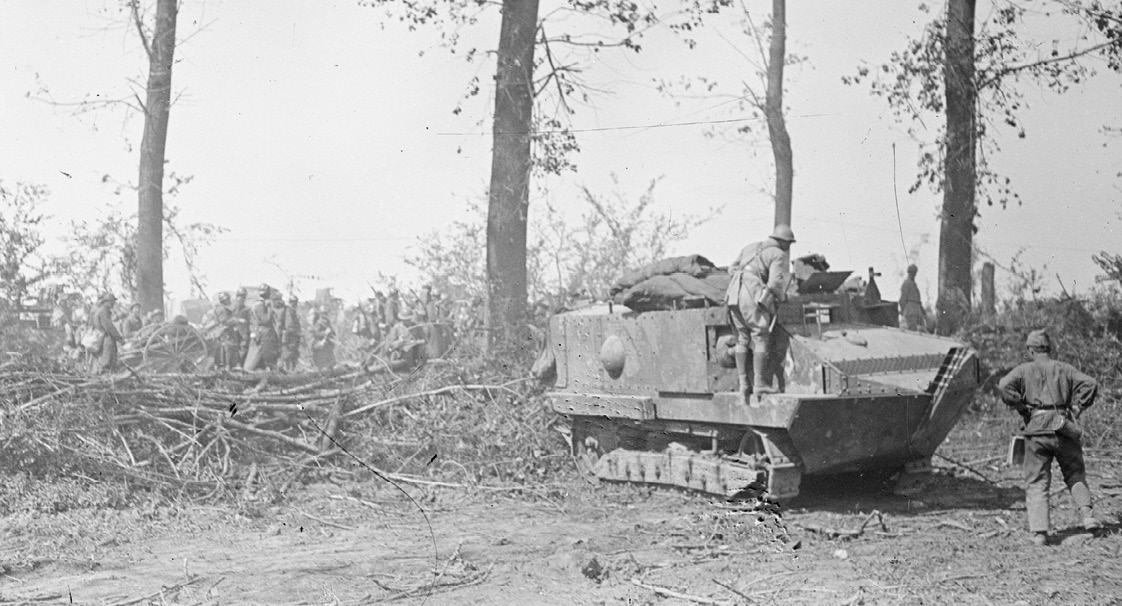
[0,352,563,509]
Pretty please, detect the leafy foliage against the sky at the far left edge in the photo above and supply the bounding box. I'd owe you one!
[0,181,50,307]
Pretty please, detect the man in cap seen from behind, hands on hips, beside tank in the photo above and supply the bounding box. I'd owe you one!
[997,330,1102,545]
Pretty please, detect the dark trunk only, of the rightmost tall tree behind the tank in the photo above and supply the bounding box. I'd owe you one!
[936,0,976,334]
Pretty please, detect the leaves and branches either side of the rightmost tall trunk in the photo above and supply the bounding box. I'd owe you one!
[842,0,1122,208]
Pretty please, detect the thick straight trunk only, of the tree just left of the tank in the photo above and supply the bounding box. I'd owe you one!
[486,0,539,350]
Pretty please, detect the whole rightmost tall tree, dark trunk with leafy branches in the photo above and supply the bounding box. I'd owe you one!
[843,0,1122,334]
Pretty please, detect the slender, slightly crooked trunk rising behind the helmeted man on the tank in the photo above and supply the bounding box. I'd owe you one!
[764,0,794,226]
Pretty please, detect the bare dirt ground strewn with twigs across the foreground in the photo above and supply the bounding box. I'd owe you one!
[0,420,1122,606]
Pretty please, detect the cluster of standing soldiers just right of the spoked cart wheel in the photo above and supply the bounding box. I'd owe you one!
[206,284,335,371]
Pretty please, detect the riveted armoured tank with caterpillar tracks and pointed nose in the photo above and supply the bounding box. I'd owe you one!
[546,258,980,498]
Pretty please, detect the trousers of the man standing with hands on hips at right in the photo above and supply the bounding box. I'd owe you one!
[1024,434,1092,532]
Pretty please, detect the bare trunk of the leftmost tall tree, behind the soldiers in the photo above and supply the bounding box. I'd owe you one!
[134,0,177,312]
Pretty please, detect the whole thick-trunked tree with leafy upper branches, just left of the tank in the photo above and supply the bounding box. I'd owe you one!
[360,0,732,349]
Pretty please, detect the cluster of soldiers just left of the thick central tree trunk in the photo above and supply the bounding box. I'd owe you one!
[351,285,452,365]
